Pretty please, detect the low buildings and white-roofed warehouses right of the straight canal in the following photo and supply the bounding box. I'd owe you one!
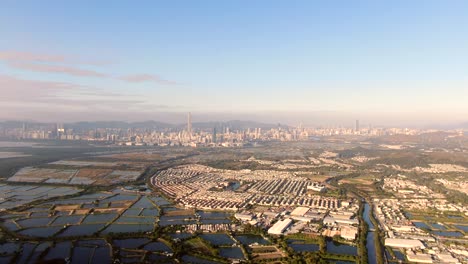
[373,172,468,263]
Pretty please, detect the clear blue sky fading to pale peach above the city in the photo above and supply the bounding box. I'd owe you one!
[0,0,468,125]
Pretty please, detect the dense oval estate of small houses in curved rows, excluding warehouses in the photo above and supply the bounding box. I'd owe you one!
[151,165,342,210]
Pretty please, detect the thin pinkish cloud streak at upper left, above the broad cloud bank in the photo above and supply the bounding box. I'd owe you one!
[8,61,108,78]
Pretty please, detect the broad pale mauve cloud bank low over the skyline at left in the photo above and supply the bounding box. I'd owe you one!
[0,74,176,114]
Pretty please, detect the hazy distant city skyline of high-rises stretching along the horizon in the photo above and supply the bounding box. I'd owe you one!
[0,112,446,147]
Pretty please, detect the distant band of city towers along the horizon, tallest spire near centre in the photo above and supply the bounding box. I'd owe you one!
[0,116,457,147]
